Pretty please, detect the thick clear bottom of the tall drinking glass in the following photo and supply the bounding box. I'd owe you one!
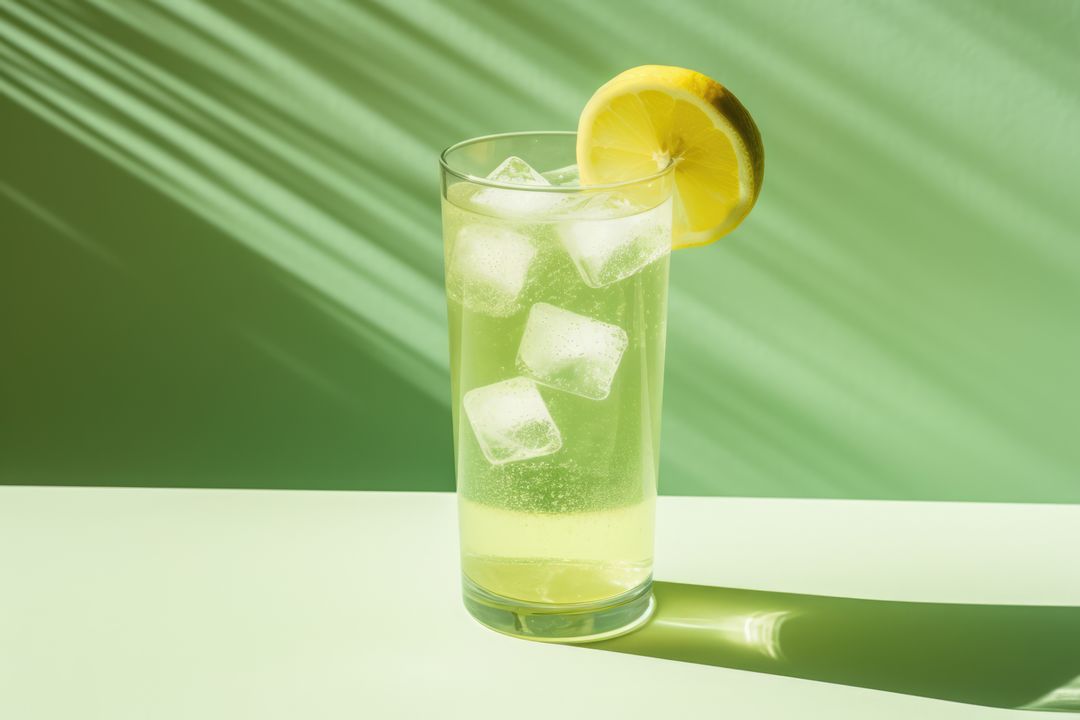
[461,575,656,642]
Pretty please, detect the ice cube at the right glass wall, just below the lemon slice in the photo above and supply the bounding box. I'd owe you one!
[558,193,672,287]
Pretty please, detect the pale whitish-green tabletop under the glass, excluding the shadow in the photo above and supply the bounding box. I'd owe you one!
[0,487,1080,720]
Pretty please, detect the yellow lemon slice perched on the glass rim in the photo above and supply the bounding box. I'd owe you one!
[577,65,765,248]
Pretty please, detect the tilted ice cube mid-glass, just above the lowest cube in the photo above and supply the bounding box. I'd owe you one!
[517,302,629,400]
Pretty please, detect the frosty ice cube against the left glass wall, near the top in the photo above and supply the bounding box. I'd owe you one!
[446,225,537,317]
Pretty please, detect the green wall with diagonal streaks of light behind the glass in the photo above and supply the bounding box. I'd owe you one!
[0,0,1080,502]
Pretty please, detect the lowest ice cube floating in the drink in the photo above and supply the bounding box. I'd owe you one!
[462,378,563,465]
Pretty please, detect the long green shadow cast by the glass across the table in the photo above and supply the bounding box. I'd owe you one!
[584,582,1080,712]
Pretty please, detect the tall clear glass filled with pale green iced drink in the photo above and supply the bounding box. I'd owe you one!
[442,133,673,641]
